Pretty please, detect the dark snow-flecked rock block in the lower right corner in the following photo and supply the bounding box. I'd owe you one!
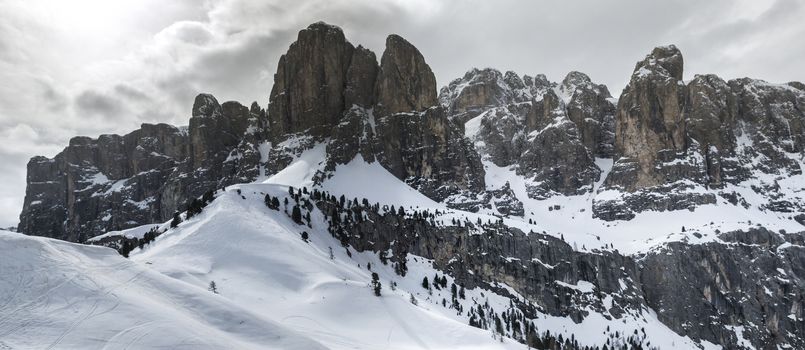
[640,228,805,349]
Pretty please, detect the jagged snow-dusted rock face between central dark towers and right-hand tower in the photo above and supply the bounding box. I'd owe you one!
[440,69,615,199]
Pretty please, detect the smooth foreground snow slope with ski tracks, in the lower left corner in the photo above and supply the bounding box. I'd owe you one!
[0,231,324,349]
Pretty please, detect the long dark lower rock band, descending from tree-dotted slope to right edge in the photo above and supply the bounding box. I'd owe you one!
[316,193,805,349]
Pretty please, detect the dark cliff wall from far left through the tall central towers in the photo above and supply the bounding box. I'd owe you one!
[19,22,485,241]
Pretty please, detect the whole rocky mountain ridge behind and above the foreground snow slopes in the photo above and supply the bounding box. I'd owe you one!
[12,23,805,348]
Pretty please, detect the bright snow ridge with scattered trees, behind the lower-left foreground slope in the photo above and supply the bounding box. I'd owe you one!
[131,184,522,349]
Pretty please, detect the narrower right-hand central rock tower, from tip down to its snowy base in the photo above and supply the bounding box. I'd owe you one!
[374,35,484,204]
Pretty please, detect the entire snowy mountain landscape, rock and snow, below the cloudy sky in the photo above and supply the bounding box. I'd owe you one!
[12,23,805,349]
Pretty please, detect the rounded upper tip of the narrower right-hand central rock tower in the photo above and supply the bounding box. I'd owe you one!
[375,34,437,116]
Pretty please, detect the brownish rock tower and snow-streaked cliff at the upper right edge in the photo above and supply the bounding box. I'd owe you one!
[593,46,805,220]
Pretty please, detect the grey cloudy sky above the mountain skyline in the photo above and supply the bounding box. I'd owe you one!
[0,0,805,227]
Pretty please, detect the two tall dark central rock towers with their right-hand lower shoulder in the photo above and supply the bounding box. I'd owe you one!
[268,23,484,210]
